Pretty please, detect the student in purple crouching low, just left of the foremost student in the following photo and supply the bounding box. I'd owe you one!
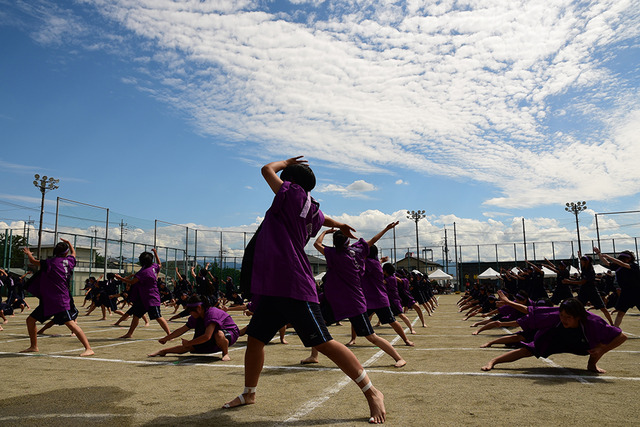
[149,295,240,361]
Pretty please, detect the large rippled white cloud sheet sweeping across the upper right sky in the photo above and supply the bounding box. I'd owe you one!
[8,0,640,208]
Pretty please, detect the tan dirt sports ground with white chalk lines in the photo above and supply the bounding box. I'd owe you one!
[0,295,640,427]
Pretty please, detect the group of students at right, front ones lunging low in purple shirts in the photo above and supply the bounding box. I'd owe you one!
[458,252,640,373]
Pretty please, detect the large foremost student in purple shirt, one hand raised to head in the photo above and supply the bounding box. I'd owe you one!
[223,156,386,424]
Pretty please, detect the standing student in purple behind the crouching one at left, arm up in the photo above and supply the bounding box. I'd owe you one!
[115,248,171,338]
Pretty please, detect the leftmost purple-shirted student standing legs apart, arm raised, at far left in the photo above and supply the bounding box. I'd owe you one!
[21,239,94,356]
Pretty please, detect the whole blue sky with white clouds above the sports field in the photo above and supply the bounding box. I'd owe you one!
[0,0,640,260]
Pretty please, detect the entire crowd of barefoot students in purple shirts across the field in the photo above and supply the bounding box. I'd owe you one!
[0,156,640,424]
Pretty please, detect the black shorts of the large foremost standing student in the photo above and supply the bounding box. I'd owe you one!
[247,296,333,347]
